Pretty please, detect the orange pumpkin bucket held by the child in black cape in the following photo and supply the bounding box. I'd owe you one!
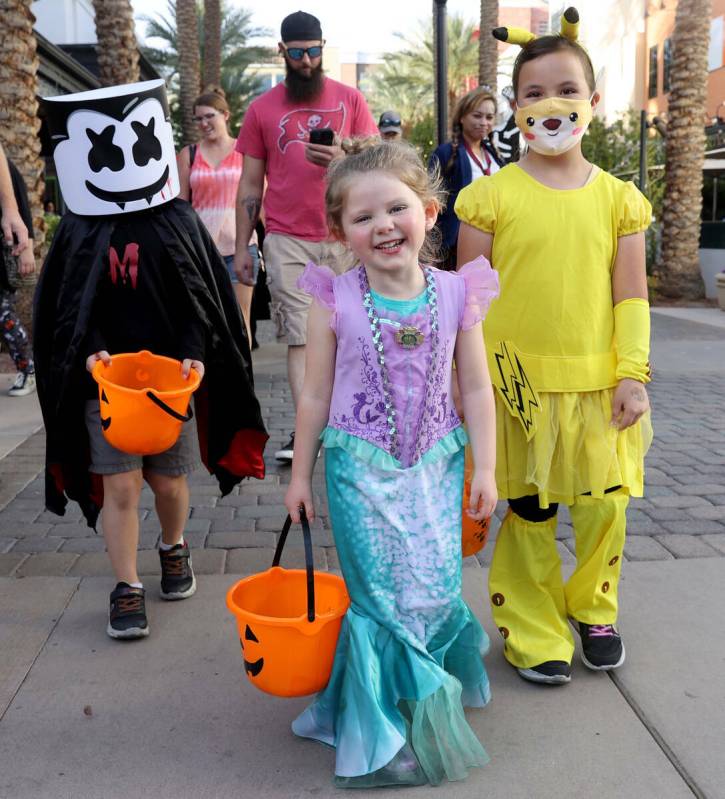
[92,350,201,455]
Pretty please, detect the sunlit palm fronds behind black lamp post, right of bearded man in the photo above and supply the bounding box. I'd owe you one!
[371,15,480,124]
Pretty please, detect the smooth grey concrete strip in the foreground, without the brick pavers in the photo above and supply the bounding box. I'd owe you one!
[0,559,725,799]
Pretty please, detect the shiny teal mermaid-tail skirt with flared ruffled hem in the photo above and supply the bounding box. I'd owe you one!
[292,447,491,787]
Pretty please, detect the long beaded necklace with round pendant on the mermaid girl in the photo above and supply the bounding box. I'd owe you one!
[358,264,439,463]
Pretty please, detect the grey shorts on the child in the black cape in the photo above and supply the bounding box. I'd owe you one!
[86,399,199,477]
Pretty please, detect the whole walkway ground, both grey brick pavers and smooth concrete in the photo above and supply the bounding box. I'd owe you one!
[0,309,725,799]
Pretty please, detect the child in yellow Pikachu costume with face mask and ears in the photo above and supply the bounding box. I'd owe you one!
[455,8,652,684]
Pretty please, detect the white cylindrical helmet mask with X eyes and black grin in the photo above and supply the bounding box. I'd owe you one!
[43,80,179,216]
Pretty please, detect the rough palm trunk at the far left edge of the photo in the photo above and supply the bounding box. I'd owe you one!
[0,0,45,258]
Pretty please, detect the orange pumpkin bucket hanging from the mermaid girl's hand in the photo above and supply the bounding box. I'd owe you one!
[227,514,350,696]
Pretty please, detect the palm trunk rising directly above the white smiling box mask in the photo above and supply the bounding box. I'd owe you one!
[93,0,140,86]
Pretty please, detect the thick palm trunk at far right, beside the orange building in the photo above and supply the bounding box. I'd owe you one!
[657,0,711,299]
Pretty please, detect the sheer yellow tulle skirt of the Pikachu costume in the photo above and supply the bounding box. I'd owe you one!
[496,388,652,508]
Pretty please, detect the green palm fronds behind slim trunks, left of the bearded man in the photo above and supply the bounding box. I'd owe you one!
[142,0,273,138]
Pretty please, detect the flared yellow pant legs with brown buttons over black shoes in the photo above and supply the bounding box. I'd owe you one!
[488,489,629,669]
